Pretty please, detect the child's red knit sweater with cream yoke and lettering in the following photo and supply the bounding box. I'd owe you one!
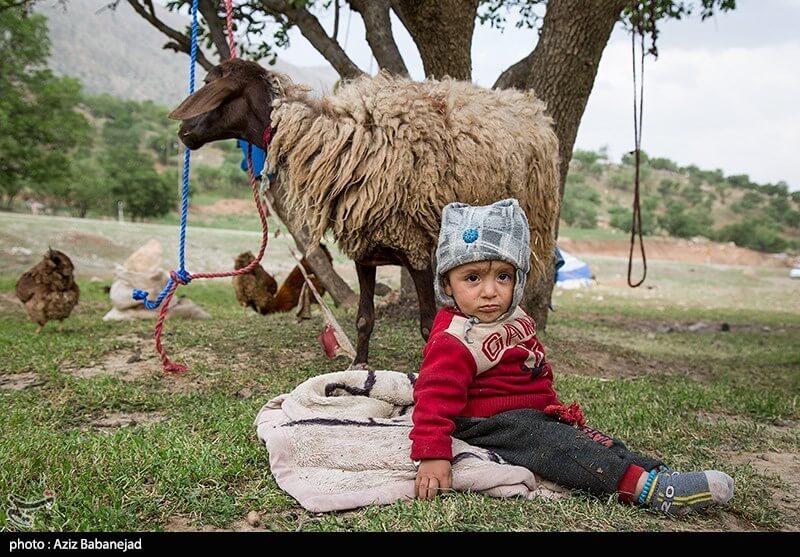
[409,307,560,460]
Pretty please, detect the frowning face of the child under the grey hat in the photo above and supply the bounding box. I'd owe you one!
[444,260,517,323]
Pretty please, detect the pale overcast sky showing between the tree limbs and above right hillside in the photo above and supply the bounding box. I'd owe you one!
[270,0,800,190]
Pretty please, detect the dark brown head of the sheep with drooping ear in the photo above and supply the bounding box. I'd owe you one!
[169,58,278,149]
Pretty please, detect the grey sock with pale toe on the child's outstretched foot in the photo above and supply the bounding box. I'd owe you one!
[638,470,733,514]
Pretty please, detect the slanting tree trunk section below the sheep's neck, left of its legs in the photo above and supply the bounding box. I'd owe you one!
[269,181,358,307]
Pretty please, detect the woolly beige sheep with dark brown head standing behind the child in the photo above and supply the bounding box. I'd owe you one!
[170,59,560,364]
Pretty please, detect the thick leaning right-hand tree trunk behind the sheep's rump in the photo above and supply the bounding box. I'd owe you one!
[516,0,628,330]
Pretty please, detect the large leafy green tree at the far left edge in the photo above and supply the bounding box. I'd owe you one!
[0,6,90,209]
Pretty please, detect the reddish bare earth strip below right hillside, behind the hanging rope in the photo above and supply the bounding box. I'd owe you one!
[558,236,792,267]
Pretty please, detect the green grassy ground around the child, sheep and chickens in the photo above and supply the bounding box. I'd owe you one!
[0,215,800,531]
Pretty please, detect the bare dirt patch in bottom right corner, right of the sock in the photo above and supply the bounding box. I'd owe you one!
[729,452,800,532]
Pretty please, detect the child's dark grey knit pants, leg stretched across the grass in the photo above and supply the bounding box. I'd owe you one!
[453,408,663,494]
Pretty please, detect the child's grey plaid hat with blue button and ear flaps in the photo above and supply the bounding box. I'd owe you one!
[434,199,531,313]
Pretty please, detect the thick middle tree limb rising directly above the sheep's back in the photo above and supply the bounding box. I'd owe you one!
[393,0,478,81]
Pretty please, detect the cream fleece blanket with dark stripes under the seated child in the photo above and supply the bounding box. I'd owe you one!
[254,370,563,512]
